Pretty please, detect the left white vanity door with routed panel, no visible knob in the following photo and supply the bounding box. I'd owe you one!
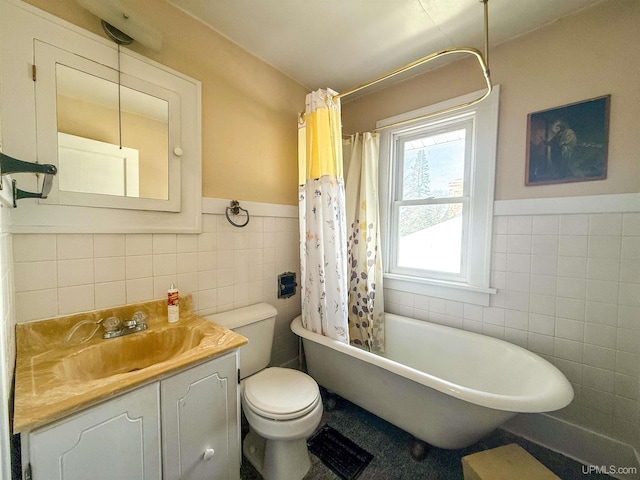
[29,382,162,480]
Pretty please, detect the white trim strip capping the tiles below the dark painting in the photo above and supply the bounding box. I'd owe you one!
[493,193,640,216]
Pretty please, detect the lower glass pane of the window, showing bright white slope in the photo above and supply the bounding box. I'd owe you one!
[398,203,462,273]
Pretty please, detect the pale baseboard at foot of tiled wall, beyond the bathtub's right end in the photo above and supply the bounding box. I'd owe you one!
[501,413,640,480]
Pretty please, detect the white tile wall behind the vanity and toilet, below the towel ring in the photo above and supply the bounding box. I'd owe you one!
[12,215,300,365]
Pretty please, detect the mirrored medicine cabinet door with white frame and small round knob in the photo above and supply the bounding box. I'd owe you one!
[34,41,183,212]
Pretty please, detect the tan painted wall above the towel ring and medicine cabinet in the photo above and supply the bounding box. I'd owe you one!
[26,0,307,205]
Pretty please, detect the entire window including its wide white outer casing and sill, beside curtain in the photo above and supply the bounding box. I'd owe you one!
[377,86,499,305]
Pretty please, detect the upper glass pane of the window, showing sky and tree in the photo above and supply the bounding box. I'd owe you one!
[401,128,466,200]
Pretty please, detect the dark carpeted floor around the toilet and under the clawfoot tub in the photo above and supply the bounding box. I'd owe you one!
[240,391,612,480]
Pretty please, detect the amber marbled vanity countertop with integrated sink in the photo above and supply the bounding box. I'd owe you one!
[13,296,247,433]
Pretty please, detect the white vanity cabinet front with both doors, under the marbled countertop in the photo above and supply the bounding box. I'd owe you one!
[23,352,240,480]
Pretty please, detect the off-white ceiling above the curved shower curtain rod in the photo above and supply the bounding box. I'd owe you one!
[169,0,602,96]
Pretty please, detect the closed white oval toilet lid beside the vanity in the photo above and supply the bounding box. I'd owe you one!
[243,367,320,420]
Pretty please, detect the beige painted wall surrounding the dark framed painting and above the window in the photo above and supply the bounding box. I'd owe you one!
[342,0,640,200]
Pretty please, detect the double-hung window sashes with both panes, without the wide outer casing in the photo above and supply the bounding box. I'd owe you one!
[389,117,473,279]
